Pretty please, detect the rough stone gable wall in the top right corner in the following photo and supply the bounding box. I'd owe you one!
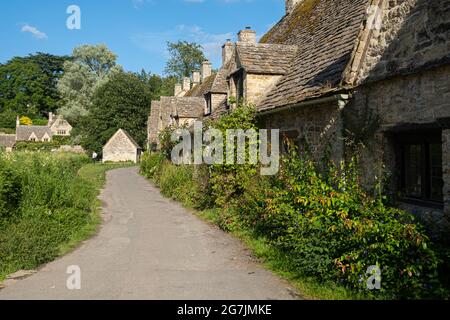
[358,0,450,83]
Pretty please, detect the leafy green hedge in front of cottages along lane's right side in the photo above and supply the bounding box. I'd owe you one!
[141,106,448,299]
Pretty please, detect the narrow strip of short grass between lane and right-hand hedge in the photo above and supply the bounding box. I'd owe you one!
[197,208,368,300]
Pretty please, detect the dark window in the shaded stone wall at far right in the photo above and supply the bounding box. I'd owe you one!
[399,131,444,203]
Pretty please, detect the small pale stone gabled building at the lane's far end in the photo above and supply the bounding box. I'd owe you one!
[102,129,142,163]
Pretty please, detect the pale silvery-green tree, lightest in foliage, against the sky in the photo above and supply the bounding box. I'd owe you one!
[58,45,122,124]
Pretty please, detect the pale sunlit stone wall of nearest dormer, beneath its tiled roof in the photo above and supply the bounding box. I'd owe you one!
[245,74,282,105]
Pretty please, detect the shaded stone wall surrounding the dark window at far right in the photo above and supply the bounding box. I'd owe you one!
[344,65,450,236]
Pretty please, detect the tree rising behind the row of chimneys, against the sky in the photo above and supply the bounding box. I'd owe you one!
[165,41,206,79]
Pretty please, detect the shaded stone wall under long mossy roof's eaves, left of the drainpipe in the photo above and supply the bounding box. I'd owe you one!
[261,102,343,163]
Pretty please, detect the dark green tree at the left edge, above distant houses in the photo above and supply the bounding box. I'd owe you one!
[0,52,69,127]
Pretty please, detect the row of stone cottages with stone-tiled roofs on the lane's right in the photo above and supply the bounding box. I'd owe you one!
[149,0,450,235]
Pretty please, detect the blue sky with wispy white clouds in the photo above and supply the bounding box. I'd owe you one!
[0,0,284,74]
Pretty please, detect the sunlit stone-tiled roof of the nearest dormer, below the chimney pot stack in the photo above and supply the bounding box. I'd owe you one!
[236,42,298,75]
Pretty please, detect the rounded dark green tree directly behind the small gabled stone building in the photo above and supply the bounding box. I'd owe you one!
[76,72,152,153]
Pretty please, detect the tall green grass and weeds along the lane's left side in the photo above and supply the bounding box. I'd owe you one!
[0,152,135,282]
